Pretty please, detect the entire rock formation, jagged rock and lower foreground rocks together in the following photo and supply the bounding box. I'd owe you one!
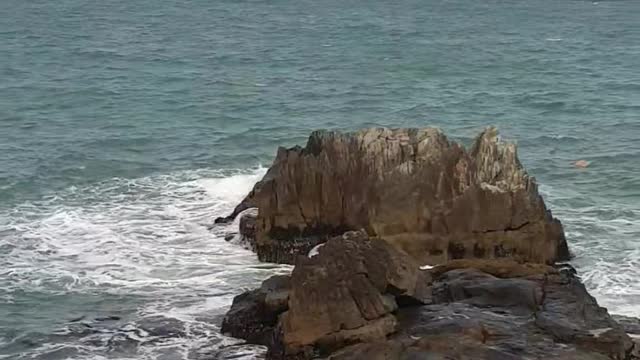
[216,128,640,360]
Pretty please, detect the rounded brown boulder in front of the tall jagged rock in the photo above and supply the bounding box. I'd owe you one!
[280,233,430,356]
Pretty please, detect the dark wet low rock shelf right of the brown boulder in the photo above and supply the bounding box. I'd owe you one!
[329,269,635,360]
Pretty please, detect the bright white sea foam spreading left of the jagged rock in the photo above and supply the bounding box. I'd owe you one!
[0,168,290,359]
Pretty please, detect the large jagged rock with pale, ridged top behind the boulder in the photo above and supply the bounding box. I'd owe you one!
[217,128,569,263]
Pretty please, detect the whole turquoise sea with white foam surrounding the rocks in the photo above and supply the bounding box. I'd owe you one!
[0,0,640,359]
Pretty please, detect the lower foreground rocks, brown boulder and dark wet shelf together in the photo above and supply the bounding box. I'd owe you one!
[219,238,638,360]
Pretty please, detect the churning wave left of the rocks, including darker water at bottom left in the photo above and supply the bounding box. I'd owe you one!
[0,167,290,359]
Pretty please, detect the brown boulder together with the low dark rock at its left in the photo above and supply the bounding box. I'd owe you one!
[222,232,431,358]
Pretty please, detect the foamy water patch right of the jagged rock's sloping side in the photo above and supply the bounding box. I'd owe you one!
[540,185,640,316]
